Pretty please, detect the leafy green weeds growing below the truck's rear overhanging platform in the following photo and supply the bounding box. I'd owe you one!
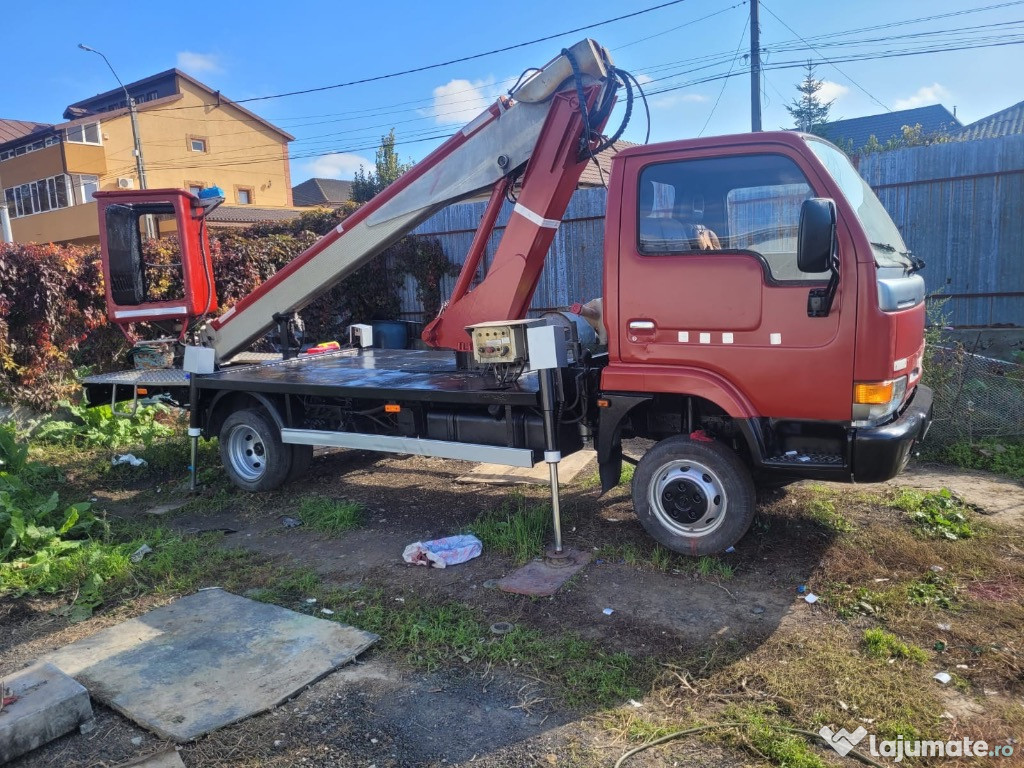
[33,400,174,449]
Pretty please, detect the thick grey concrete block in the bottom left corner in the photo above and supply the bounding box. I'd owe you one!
[0,662,92,765]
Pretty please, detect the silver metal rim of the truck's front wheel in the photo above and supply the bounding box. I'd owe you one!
[647,461,728,538]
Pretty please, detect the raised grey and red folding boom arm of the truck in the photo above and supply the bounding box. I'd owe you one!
[204,40,615,361]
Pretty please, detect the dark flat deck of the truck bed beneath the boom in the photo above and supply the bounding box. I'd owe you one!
[194,349,540,406]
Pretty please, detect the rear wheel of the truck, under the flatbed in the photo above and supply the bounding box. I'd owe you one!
[220,410,293,492]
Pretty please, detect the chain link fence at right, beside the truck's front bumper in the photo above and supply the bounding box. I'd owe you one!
[925,345,1024,444]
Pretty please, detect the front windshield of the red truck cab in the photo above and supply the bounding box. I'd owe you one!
[806,136,913,268]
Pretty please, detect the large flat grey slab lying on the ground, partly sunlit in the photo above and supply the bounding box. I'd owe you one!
[46,589,378,742]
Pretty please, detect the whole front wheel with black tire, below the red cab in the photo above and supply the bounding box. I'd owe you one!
[633,435,757,557]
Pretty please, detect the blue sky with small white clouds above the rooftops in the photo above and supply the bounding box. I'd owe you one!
[0,0,1024,183]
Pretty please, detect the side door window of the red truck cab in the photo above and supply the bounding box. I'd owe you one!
[637,155,825,281]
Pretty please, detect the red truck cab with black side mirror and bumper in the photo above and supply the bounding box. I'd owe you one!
[598,132,932,548]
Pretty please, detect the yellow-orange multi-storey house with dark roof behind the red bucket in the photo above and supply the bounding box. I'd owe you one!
[0,70,299,243]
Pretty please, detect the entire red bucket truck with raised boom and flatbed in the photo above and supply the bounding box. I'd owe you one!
[83,40,932,555]
